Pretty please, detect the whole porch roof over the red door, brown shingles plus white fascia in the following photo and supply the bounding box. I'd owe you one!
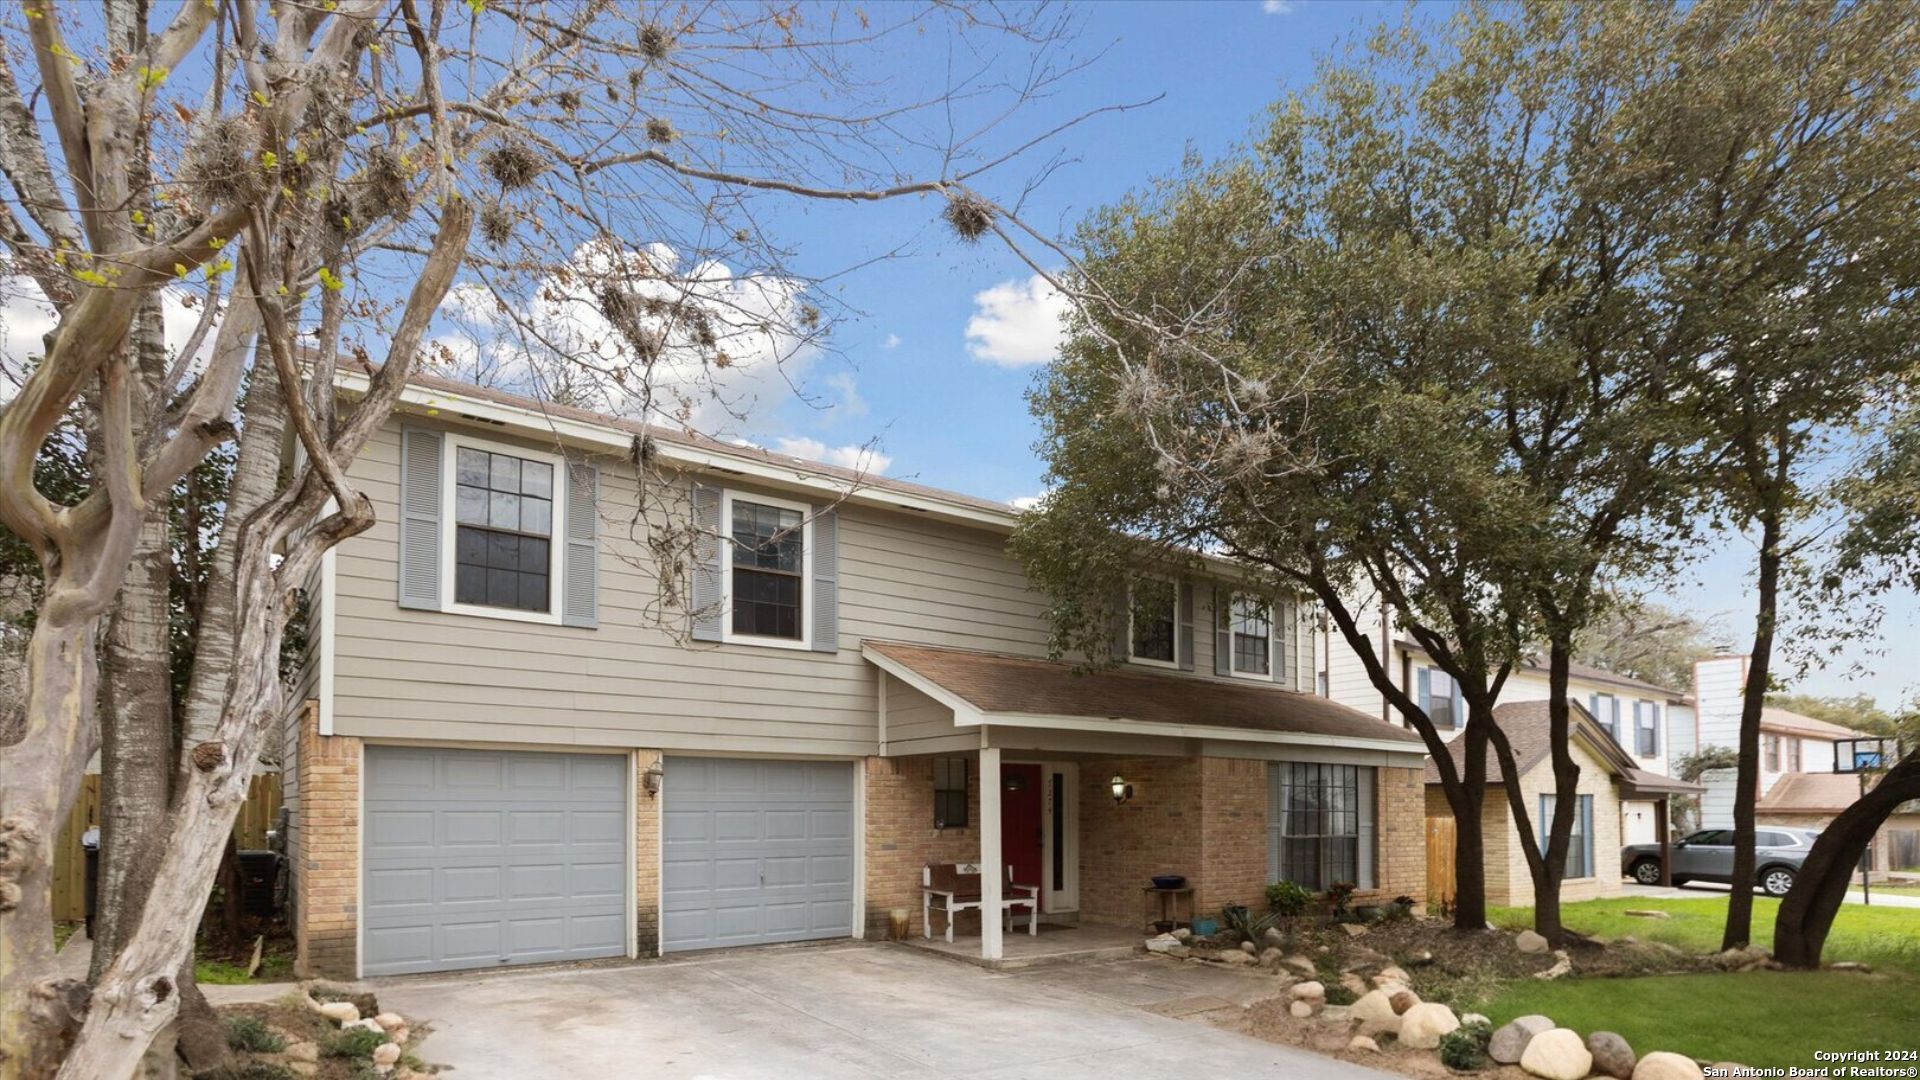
[862,640,1425,755]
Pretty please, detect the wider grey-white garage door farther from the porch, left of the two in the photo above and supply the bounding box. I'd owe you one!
[361,746,630,974]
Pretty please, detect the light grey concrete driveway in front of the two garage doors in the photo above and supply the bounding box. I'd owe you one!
[374,944,1388,1080]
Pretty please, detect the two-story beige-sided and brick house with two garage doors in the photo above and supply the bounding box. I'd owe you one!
[286,377,1425,976]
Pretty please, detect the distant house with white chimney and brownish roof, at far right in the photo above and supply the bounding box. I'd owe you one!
[1693,655,1920,871]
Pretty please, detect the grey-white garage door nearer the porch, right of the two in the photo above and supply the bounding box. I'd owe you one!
[660,757,854,951]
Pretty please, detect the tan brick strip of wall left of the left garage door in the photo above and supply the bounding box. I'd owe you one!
[288,701,361,978]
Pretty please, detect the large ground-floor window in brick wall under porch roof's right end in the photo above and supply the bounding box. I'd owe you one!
[1267,761,1375,892]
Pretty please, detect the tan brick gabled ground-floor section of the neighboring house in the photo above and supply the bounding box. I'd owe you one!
[1427,700,1699,907]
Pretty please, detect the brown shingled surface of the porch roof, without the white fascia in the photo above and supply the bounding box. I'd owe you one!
[864,640,1423,753]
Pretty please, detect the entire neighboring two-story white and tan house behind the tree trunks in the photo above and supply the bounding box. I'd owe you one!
[1315,607,1701,905]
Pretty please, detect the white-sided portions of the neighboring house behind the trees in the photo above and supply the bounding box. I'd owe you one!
[1315,611,1693,844]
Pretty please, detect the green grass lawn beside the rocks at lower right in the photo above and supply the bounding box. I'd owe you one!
[1478,897,1920,1067]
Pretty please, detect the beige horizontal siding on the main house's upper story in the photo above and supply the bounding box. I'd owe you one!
[334,423,1320,755]
